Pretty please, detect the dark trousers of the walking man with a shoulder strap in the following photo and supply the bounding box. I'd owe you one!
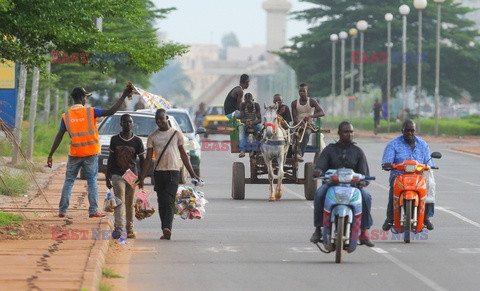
[153,171,180,230]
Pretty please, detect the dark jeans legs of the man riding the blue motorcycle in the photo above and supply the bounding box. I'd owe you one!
[313,184,373,229]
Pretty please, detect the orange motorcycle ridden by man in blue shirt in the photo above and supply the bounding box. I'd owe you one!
[384,152,442,243]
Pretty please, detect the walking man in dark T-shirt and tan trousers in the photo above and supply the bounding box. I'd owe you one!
[105,114,145,239]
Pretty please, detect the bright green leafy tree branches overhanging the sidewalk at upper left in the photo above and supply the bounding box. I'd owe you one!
[0,0,186,73]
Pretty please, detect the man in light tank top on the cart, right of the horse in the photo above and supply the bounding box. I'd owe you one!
[291,83,325,162]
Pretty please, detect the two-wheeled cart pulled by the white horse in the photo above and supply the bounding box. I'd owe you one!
[229,112,330,200]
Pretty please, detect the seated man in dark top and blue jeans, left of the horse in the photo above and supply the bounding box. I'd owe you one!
[238,93,262,158]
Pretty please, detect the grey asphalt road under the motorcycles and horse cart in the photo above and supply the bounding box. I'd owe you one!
[128,135,480,290]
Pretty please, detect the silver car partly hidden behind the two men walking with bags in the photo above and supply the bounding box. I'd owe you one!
[80,110,191,185]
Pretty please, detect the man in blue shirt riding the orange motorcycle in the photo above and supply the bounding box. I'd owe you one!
[382,119,435,231]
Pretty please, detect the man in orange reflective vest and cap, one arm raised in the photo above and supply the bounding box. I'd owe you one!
[47,85,133,218]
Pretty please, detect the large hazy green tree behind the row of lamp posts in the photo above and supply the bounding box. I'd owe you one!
[278,0,480,100]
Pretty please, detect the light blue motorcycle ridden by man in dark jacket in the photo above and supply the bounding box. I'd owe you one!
[317,168,375,263]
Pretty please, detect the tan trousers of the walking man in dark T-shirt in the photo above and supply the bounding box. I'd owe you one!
[112,175,135,232]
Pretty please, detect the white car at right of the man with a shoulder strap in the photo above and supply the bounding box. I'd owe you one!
[167,108,205,176]
